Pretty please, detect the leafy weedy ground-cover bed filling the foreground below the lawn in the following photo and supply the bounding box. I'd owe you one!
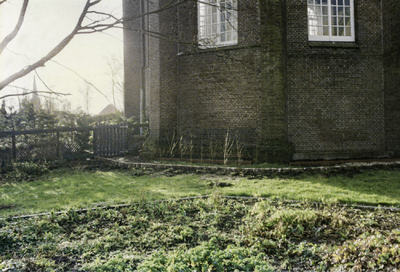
[0,198,400,271]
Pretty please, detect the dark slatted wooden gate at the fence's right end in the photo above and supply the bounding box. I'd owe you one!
[93,124,128,156]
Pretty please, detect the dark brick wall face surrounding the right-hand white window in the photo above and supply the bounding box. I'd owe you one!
[286,0,385,159]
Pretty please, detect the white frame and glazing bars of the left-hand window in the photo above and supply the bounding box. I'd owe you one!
[197,0,239,48]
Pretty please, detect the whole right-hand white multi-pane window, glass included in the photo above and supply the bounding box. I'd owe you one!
[307,0,355,42]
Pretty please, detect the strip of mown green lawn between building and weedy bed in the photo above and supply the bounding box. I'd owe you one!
[0,166,400,217]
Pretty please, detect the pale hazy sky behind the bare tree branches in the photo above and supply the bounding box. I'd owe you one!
[0,0,123,114]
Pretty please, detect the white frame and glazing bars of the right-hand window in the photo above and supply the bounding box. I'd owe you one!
[307,0,355,42]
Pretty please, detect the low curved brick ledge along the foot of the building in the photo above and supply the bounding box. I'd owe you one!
[95,157,400,176]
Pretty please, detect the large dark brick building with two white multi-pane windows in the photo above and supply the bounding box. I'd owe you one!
[124,0,400,160]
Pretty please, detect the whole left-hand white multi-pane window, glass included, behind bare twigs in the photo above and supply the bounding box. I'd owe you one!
[198,0,238,48]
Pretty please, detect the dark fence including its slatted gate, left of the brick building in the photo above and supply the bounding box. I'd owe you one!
[0,124,128,163]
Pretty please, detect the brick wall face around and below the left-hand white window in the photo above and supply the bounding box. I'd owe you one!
[172,0,261,147]
